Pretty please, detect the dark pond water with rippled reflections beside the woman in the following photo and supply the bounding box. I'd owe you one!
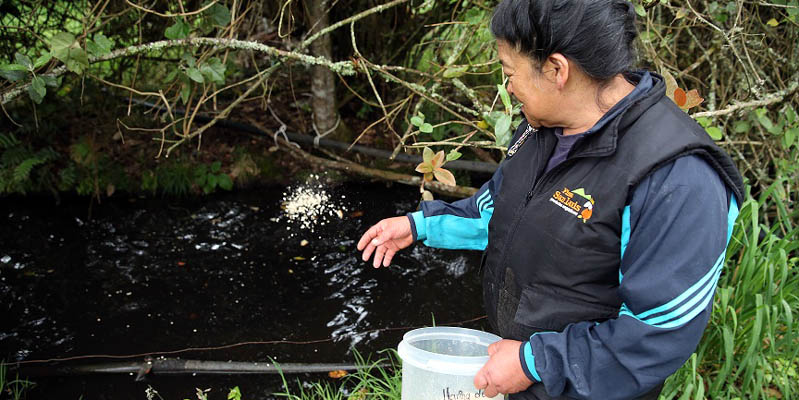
[0,179,485,399]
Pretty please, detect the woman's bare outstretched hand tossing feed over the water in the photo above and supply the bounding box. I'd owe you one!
[358,217,413,268]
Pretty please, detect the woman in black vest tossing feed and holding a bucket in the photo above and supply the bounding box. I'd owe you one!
[358,0,742,399]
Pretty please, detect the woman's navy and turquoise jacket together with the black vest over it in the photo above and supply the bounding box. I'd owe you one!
[409,74,743,399]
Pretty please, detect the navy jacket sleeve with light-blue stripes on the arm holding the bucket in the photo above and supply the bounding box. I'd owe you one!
[520,156,738,399]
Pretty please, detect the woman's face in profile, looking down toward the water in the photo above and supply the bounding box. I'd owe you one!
[497,40,559,126]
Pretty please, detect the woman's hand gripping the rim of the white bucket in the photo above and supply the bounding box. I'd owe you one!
[474,339,533,398]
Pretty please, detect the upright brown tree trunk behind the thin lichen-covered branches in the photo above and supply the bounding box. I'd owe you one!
[305,0,338,138]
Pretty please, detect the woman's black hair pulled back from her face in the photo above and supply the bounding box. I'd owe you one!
[491,0,638,82]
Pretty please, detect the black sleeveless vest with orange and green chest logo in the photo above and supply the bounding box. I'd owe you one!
[482,74,743,398]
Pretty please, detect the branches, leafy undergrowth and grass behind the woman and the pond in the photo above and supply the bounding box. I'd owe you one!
[0,0,799,399]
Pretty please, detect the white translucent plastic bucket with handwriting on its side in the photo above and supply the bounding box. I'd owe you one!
[397,327,504,400]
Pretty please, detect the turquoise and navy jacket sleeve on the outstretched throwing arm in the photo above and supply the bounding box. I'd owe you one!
[408,162,502,250]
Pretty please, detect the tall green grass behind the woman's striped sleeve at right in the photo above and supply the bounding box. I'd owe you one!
[661,182,799,400]
